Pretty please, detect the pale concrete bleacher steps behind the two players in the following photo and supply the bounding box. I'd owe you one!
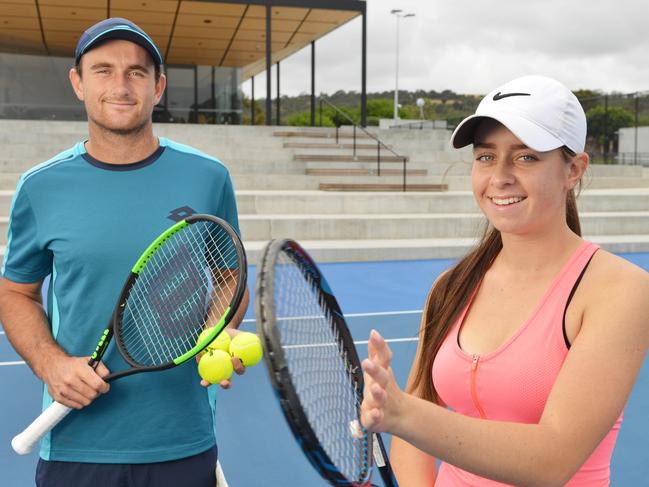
[0,121,649,262]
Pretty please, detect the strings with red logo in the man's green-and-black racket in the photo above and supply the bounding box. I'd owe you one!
[120,222,239,366]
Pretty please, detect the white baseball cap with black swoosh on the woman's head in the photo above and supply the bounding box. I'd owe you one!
[451,76,586,152]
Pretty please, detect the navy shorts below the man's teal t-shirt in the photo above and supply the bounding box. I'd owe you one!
[36,446,217,487]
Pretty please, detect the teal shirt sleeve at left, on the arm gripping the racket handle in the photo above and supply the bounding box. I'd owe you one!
[2,180,52,283]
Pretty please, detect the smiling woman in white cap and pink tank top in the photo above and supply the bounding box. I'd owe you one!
[361,76,649,487]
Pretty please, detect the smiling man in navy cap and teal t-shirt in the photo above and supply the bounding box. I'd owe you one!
[0,18,248,487]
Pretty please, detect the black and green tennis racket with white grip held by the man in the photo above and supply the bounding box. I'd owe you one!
[11,215,247,454]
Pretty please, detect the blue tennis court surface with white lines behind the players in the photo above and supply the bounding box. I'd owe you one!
[0,254,649,487]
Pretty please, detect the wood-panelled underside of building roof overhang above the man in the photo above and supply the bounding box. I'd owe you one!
[0,0,365,80]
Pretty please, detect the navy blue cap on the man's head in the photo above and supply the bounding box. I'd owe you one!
[74,17,164,66]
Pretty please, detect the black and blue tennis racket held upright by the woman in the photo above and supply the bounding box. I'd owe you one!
[255,239,397,487]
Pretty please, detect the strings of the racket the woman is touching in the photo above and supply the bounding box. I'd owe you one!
[274,253,371,482]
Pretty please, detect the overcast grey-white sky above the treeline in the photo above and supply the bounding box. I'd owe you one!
[243,0,649,99]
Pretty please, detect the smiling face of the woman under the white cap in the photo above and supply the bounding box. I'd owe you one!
[471,119,587,235]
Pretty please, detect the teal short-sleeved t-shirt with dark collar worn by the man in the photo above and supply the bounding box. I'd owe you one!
[2,138,238,463]
